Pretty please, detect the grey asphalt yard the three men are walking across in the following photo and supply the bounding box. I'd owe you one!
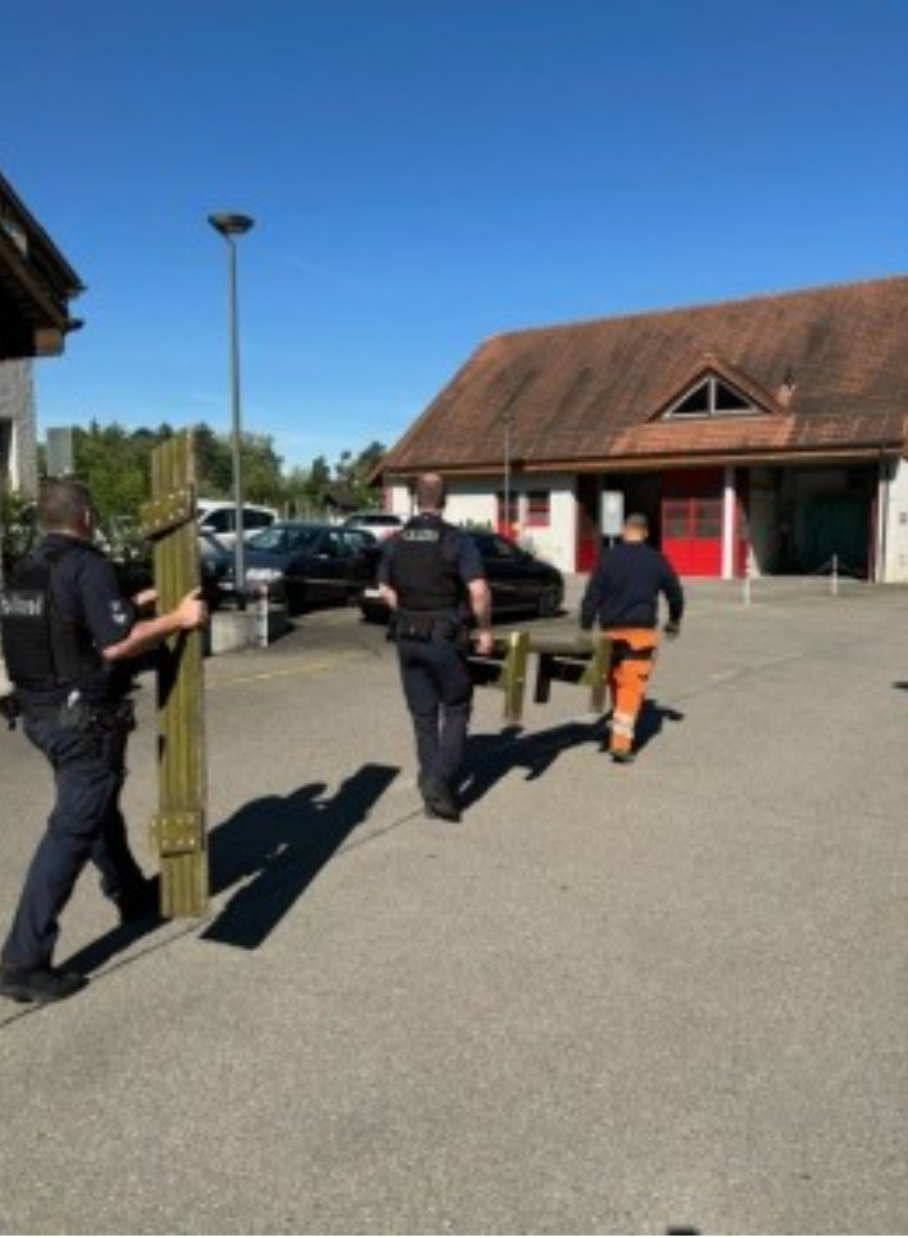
[0,583,908,1234]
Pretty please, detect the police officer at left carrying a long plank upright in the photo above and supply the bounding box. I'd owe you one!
[0,479,207,1003]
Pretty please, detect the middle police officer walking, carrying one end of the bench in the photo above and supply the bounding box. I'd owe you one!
[379,473,494,821]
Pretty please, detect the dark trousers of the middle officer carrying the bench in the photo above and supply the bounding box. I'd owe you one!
[398,635,473,790]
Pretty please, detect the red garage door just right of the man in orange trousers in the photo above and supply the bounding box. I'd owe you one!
[661,469,722,576]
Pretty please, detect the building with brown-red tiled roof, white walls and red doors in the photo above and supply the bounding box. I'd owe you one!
[383,276,908,581]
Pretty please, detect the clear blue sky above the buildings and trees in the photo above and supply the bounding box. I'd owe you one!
[0,0,908,465]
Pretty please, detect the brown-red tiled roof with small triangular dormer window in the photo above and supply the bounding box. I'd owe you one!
[383,276,908,474]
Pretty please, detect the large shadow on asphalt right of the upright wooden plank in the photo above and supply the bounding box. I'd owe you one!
[201,765,400,950]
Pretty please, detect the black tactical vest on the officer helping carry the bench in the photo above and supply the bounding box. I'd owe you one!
[390,520,466,615]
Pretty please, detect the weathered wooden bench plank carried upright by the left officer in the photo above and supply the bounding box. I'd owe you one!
[142,433,208,917]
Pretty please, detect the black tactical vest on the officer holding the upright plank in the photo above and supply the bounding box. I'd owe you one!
[0,545,104,692]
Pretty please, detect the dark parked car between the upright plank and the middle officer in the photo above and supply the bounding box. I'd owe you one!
[228,520,378,613]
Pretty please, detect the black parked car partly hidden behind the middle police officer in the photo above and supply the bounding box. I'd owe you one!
[359,530,565,621]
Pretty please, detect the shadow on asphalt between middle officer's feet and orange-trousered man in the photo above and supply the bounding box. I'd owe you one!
[460,718,606,808]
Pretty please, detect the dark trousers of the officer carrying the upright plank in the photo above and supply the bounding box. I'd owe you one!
[2,716,144,967]
